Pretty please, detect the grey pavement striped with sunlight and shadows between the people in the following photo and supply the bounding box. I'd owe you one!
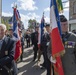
[17,47,46,75]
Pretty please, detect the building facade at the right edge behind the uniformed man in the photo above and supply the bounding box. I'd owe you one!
[69,0,76,31]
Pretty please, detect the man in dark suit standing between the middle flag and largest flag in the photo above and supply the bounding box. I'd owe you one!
[41,24,51,75]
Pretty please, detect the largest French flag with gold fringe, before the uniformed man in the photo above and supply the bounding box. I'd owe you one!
[50,0,65,75]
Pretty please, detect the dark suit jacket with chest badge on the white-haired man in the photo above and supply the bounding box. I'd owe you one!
[0,37,15,72]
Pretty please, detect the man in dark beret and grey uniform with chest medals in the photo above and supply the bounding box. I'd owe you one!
[60,15,76,75]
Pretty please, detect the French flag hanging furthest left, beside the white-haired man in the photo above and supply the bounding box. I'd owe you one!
[13,8,22,61]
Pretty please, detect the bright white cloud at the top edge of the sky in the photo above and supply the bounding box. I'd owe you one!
[17,0,38,11]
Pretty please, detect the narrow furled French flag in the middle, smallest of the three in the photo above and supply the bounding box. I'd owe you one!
[38,13,45,48]
